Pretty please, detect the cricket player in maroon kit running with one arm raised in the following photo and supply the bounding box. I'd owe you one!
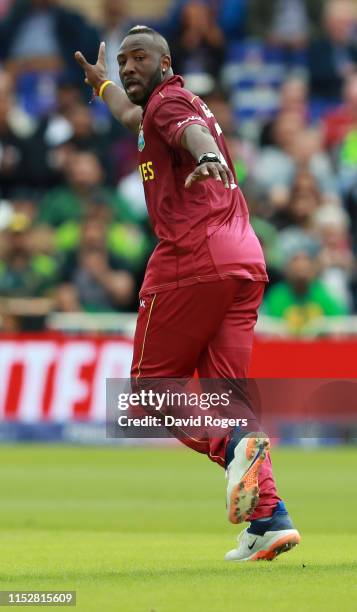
[76,26,300,561]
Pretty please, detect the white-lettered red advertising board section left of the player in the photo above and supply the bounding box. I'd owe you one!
[0,336,132,423]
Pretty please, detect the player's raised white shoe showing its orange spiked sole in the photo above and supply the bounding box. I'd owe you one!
[226,433,270,524]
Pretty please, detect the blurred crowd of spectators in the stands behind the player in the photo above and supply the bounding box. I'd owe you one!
[0,0,357,334]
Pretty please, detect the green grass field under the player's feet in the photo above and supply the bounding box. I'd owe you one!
[0,446,357,612]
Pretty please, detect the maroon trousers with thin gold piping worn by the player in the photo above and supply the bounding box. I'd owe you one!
[131,278,280,519]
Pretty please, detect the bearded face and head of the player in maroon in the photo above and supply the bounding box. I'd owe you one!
[118,34,170,106]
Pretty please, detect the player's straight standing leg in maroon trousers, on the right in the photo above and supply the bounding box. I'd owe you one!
[198,280,280,519]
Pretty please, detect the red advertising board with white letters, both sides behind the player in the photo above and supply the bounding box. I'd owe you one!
[0,335,357,423]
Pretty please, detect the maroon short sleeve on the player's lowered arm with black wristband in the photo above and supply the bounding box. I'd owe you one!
[152,97,209,147]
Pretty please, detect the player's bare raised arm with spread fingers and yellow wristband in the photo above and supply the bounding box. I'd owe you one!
[75,42,142,134]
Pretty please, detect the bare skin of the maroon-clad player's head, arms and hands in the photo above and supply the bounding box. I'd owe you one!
[75,33,235,189]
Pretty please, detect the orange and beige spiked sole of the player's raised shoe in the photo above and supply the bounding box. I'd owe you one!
[228,438,270,525]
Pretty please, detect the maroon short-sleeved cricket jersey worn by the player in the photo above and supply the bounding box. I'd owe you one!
[138,76,267,295]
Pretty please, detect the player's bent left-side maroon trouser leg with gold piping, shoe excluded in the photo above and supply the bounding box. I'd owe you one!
[131,279,237,456]
